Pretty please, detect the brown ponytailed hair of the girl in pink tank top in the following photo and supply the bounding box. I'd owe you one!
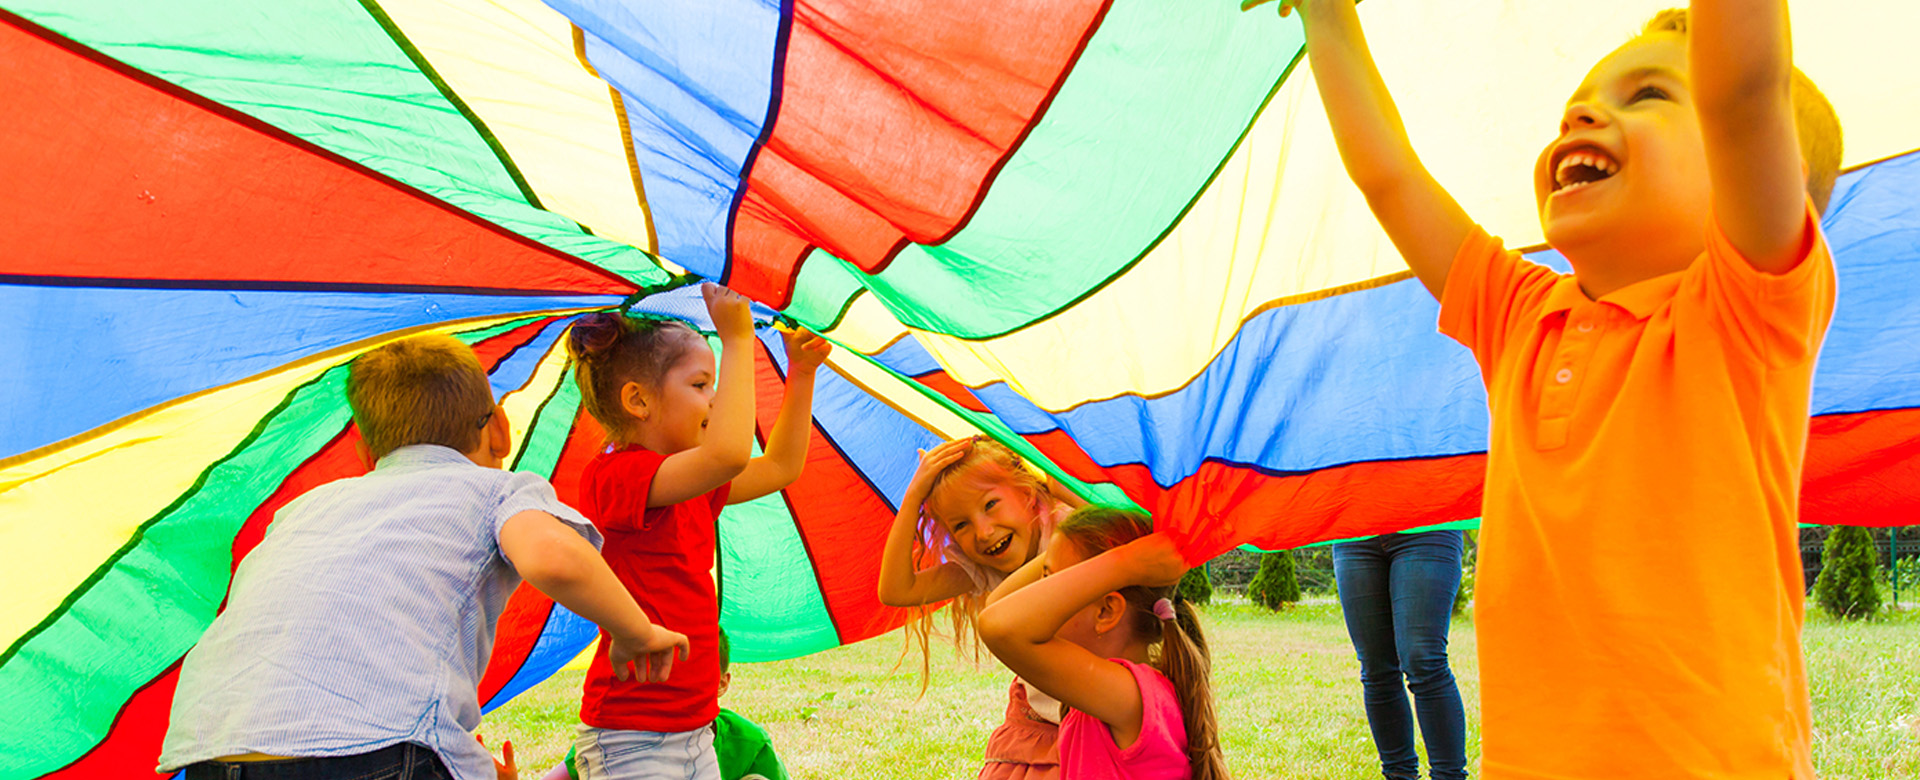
[1054,505,1229,780]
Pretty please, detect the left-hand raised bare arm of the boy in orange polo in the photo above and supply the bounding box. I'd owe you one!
[1242,0,1473,298]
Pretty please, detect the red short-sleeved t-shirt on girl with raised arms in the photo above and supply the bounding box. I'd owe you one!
[580,446,728,732]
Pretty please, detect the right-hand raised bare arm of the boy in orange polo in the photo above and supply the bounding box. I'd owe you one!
[1688,0,1807,273]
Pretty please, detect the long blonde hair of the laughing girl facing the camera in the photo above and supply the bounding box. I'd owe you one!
[900,438,1058,694]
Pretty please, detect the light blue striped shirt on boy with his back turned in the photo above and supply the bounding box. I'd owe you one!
[159,444,601,780]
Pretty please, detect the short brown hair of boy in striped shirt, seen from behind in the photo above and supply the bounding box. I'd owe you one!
[348,334,493,459]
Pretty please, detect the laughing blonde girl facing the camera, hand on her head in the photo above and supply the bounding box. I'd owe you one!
[879,436,1085,780]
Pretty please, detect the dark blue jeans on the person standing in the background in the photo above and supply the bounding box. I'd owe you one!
[1332,530,1467,780]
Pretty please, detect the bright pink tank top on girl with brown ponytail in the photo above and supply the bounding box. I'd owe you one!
[1060,659,1192,780]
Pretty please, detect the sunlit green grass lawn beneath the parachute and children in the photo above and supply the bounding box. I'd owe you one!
[482,599,1920,780]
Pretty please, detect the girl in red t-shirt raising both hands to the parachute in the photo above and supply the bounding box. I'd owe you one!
[566,284,831,780]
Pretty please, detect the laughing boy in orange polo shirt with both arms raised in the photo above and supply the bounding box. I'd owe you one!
[1281,0,1839,780]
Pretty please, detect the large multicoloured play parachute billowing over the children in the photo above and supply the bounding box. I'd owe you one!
[0,0,1920,778]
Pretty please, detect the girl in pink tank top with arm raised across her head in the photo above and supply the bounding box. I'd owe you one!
[979,507,1227,780]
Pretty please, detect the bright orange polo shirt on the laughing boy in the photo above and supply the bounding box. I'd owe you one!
[1440,209,1834,780]
